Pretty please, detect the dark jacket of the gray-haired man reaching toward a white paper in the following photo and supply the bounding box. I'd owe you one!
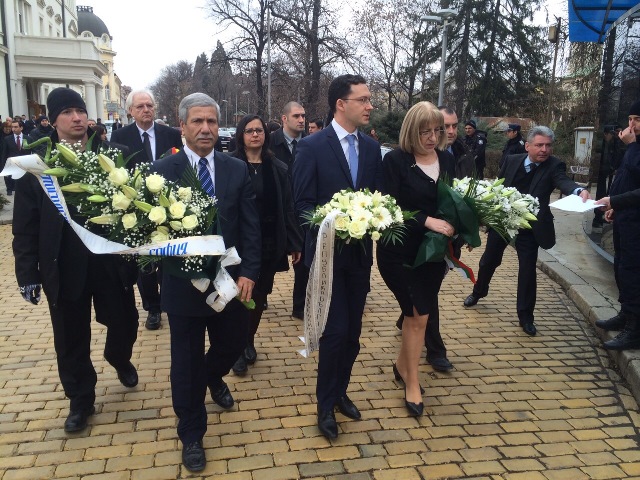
[498,153,580,249]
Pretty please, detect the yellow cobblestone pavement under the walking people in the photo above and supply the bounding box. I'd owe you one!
[0,225,640,480]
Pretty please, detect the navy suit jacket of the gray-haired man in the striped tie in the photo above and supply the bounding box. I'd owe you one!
[151,149,262,316]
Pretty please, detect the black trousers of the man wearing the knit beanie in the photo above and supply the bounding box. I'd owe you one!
[49,262,138,410]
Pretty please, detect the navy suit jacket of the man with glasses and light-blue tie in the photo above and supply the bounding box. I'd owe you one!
[293,125,384,266]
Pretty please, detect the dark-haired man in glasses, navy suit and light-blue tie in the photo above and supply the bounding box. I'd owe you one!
[293,75,384,439]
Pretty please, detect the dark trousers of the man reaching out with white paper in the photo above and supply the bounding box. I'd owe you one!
[473,230,539,323]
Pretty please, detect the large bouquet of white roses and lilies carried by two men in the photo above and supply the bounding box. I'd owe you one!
[29,138,216,273]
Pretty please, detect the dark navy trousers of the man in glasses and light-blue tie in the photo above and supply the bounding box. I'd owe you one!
[316,256,371,410]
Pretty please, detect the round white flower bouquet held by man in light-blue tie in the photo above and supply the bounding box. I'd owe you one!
[306,189,415,244]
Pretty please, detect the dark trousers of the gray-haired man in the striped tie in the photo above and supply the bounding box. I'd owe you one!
[168,300,249,445]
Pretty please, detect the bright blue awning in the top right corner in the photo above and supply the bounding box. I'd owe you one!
[568,0,640,43]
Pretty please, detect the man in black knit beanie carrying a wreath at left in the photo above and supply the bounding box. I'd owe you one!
[13,88,138,432]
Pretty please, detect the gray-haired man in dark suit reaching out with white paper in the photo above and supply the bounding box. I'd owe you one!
[464,126,589,335]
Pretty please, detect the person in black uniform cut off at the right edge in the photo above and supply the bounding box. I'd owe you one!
[596,100,640,350]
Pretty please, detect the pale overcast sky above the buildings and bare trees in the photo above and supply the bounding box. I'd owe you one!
[77,0,567,90]
